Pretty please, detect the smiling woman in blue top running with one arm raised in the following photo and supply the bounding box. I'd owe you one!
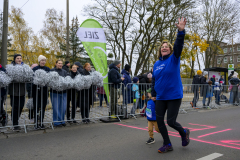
[152,17,190,153]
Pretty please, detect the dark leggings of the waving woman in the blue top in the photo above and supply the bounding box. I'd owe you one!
[155,99,186,145]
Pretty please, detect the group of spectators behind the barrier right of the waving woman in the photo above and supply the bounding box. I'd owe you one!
[190,70,239,109]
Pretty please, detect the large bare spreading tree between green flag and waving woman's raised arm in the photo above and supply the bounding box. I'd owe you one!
[84,0,194,75]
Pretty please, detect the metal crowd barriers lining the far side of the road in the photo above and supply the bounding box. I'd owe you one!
[0,82,237,132]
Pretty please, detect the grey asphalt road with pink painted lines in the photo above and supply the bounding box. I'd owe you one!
[0,107,240,160]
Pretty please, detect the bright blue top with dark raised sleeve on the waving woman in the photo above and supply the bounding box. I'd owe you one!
[152,30,185,100]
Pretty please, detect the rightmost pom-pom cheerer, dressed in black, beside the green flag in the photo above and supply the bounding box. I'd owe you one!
[79,63,93,123]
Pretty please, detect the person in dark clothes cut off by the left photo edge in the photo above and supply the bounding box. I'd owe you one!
[0,64,6,124]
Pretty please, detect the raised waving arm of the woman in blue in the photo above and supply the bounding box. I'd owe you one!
[173,17,187,58]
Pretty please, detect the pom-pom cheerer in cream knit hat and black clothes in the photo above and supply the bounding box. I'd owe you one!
[32,55,50,129]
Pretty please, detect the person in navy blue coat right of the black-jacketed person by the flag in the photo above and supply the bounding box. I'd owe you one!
[121,64,132,104]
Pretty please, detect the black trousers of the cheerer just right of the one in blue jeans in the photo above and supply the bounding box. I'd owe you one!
[67,89,77,120]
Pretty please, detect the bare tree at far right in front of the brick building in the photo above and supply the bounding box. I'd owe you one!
[201,0,239,68]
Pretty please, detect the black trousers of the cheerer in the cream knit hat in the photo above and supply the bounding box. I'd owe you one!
[32,85,48,125]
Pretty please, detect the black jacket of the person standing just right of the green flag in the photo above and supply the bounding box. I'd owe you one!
[108,64,122,89]
